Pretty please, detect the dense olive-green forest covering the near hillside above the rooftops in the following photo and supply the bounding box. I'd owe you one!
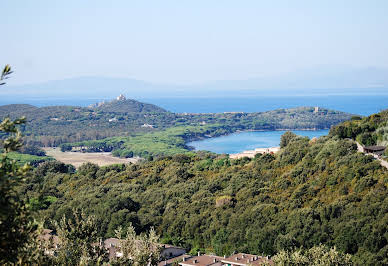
[18,111,388,265]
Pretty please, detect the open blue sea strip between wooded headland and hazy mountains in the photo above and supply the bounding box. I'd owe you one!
[0,93,388,115]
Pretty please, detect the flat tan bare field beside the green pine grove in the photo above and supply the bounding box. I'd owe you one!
[43,148,139,168]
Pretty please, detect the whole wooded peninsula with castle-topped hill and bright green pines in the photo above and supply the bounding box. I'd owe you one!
[0,95,352,158]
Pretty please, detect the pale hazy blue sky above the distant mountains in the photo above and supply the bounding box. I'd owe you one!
[0,0,388,84]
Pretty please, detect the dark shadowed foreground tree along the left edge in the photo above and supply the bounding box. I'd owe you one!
[0,65,40,265]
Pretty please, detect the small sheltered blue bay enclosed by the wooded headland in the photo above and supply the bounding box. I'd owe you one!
[188,130,329,154]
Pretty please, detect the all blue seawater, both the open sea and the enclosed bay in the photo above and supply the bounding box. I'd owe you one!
[0,93,388,153]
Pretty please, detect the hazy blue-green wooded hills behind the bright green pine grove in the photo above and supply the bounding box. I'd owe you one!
[0,99,351,146]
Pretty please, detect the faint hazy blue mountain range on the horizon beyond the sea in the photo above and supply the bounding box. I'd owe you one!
[0,67,388,100]
